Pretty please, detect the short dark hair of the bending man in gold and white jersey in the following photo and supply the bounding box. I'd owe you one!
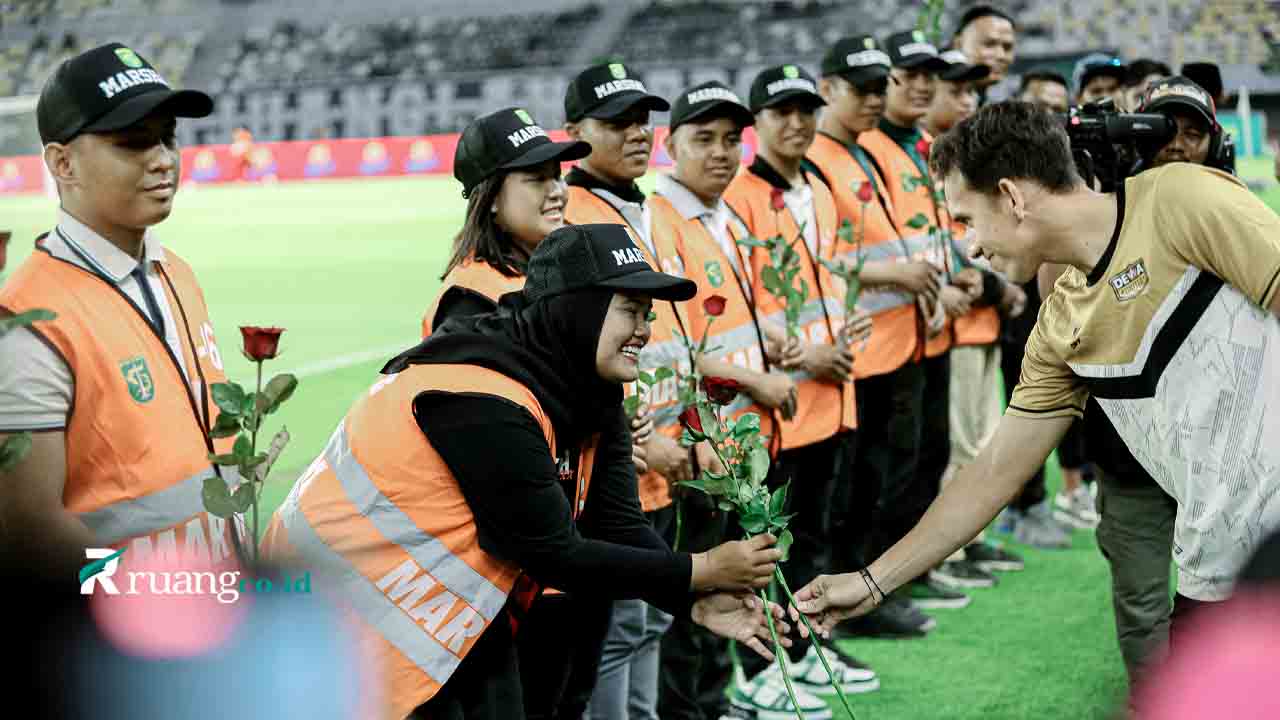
[929,100,1080,195]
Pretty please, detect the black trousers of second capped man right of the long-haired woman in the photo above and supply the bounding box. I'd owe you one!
[654,491,742,720]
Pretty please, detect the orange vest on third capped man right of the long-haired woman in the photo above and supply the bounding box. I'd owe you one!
[724,169,858,450]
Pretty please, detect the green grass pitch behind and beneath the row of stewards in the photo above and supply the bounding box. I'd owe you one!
[0,159,1280,720]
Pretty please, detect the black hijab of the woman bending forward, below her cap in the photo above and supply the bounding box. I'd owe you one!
[383,288,622,448]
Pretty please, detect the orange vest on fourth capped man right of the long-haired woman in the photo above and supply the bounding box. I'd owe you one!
[805,132,923,378]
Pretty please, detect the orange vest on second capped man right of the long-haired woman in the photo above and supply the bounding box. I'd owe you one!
[649,195,783,457]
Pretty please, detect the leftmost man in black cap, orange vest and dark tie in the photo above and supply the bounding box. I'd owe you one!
[0,44,243,573]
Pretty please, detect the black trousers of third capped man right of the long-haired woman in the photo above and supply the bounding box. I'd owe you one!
[739,432,858,676]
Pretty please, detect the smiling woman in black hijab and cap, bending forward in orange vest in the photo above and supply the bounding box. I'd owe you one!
[265,225,782,720]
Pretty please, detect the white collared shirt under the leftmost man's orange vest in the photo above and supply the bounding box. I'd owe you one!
[0,210,186,432]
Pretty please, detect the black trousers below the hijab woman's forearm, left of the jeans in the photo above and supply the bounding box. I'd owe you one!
[516,593,613,720]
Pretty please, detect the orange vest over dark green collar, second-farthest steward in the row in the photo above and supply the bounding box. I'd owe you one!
[858,128,956,357]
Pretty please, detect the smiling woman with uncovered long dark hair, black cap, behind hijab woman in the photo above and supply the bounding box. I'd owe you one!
[422,108,591,337]
